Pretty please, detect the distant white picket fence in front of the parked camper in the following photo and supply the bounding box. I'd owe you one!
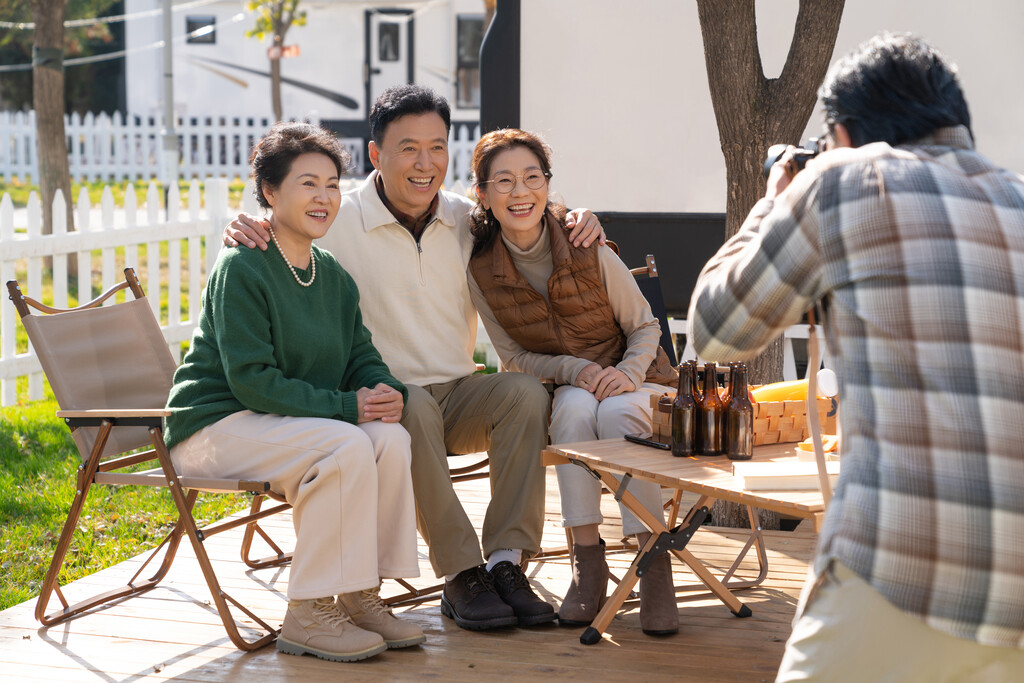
[0,112,480,186]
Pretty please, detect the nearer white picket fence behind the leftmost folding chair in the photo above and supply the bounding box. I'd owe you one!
[0,178,230,405]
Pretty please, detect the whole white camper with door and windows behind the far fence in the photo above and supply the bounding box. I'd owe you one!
[125,0,484,166]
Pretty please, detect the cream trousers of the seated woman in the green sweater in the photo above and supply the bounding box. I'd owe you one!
[171,411,420,600]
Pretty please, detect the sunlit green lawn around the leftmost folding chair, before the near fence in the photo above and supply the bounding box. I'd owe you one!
[0,395,249,609]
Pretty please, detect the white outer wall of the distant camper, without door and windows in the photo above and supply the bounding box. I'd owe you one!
[126,0,483,120]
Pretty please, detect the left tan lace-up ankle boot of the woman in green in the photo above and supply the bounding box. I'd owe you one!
[278,597,387,661]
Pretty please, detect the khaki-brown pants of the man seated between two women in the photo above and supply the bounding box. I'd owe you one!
[401,373,550,577]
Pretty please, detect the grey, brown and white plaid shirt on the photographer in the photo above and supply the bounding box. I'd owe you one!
[688,126,1024,648]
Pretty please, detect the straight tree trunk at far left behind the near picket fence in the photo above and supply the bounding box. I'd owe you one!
[32,0,77,237]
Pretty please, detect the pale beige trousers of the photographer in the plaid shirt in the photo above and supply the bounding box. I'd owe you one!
[776,560,1024,683]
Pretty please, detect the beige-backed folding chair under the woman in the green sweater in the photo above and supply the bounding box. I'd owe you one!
[7,268,290,650]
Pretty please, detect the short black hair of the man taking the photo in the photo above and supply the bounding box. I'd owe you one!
[819,33,971,146]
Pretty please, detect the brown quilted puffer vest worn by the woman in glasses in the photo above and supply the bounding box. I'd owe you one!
[469,212,678,386]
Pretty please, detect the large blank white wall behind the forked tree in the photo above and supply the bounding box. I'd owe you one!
[520,0,1024,213]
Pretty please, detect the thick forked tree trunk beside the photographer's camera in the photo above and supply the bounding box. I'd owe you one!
[697,0,844,528]
